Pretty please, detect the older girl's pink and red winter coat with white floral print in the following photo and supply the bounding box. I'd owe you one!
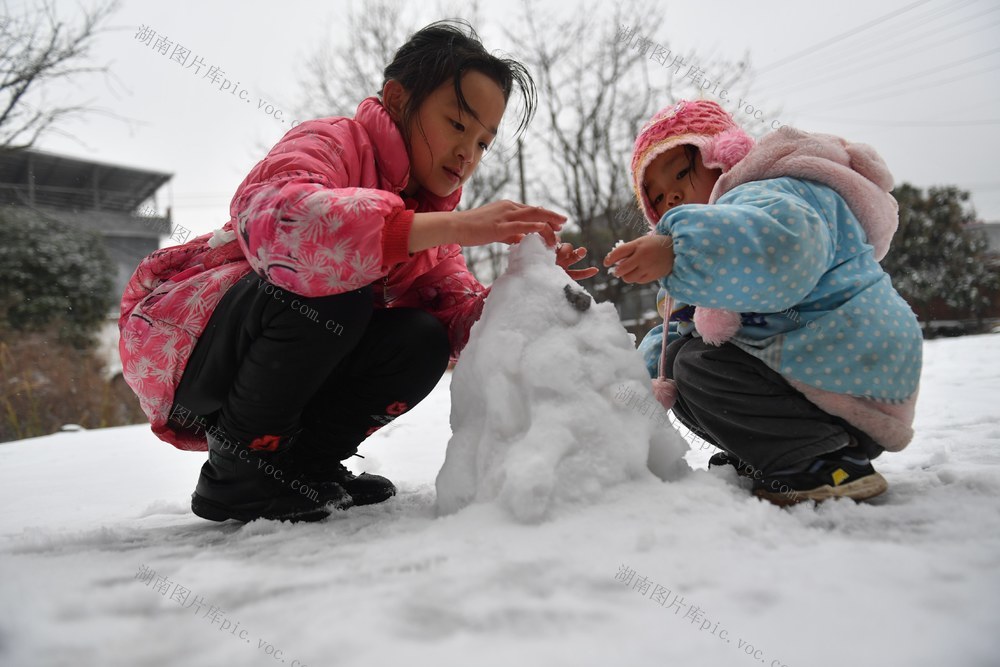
[118,97,488,450]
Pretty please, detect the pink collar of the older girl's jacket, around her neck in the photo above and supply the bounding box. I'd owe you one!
[354,97,462,211]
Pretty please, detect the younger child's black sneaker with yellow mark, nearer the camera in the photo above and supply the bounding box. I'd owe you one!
[753,447,889,506]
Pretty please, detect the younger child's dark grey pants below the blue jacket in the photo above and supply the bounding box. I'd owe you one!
[666,336,884,474]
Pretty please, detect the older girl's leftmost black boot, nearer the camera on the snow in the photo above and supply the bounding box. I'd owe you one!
[191,430,352,521]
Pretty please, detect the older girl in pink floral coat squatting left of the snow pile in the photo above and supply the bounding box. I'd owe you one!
[119,22,597,521]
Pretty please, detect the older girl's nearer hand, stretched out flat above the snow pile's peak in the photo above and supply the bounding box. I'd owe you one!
[453,200,566,246]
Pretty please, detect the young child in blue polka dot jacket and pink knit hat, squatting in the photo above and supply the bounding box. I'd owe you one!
[604,100,922,505]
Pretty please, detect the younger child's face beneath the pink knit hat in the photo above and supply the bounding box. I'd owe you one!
[642,146,722,218]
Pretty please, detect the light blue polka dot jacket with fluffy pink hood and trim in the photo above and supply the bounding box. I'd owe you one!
[639,128,922,451]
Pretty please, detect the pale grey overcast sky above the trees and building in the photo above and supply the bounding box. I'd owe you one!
[8,0,1000,240]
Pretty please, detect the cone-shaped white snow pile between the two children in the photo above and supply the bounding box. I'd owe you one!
[437,234,687,522]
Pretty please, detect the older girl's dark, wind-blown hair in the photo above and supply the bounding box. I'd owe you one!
[382,19,536,146]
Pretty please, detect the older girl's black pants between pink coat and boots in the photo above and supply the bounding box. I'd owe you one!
[174,272,450,457]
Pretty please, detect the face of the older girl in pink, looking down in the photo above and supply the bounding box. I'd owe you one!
[404,70,506,197]
